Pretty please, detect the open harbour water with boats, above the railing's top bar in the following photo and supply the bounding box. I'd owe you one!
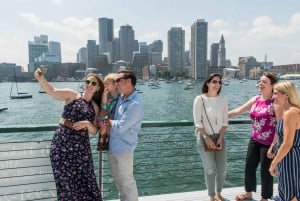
[0,80,268,125]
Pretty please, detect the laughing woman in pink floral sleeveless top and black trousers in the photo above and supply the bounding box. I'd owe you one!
[228,72,278,201]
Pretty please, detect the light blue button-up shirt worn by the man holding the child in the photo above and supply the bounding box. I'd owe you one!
[109,91,144,153]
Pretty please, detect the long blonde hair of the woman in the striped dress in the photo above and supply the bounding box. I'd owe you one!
[274,81,300,109]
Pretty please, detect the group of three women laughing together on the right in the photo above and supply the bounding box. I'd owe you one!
[193,72,300,201]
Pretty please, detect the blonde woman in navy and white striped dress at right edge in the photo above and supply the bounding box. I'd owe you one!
[269,82,300,201]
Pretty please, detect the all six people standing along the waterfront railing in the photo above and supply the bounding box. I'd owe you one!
[34,66,300,201]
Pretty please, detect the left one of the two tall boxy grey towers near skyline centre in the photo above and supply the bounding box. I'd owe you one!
[168,27,185,73]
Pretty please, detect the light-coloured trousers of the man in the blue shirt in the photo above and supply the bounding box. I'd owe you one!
[108,152,139,201]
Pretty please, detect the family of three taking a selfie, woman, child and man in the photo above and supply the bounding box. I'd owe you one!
[34,68,144,201]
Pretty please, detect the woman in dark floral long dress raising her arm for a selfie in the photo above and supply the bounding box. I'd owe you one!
[34,68,104,201]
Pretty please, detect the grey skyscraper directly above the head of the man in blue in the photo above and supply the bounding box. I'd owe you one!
[119,25,135,62]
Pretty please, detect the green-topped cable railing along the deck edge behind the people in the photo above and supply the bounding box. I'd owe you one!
[0,120,262,201]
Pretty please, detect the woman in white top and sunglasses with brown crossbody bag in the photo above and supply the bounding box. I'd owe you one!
[193,73,228,201]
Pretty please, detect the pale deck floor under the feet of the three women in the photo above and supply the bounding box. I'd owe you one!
[111,184,278,201]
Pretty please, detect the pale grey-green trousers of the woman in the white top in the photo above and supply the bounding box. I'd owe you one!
[197,134,227,197]
